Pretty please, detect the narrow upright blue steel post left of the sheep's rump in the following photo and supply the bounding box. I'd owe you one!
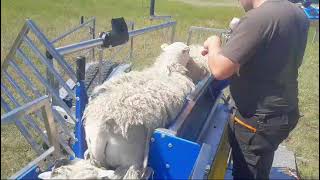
[71,81,88,159]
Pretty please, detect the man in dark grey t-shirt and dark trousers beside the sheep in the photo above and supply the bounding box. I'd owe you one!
[202,0,309,179]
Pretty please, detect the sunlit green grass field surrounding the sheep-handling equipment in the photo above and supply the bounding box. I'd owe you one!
[1,0,319,179]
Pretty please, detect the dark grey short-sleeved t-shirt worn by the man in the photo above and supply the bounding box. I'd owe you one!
[221,0,309,116]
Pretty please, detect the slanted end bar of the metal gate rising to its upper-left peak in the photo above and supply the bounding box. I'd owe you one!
[1,23,29,71]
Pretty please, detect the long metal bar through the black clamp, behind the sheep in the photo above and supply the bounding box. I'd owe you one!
[56,21,177,55]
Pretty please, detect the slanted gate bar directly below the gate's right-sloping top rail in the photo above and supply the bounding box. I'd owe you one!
[23,37,75,98]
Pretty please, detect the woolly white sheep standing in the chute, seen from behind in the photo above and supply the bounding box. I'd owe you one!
[84,42,204,178]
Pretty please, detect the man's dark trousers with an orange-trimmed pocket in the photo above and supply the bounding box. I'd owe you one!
[228,109,300,179]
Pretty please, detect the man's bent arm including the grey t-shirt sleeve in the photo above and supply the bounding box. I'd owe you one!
[202,11,273,80]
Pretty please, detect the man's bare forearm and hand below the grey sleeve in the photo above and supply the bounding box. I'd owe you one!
[202,36,240,80]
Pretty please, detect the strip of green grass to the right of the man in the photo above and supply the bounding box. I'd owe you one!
[286,29,319,179]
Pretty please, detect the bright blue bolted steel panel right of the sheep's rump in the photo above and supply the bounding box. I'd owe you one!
[149,130,200,179]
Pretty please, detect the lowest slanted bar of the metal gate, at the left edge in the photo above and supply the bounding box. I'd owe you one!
[1,97,42,155]
